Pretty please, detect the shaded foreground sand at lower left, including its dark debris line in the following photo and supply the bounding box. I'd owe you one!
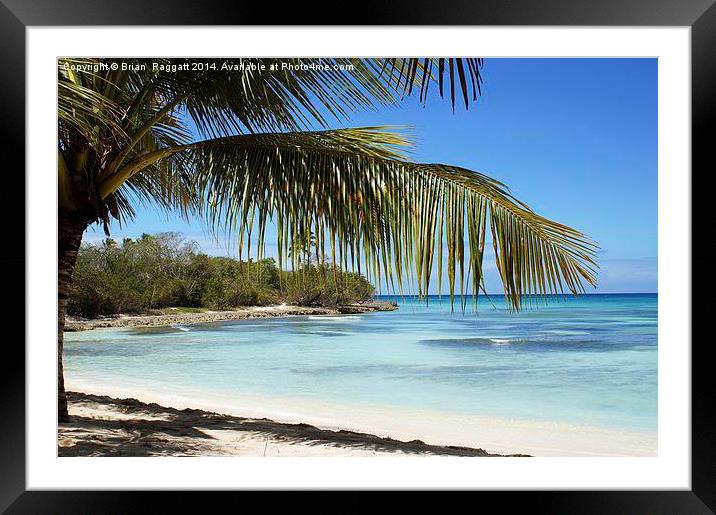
[58,391,529,457]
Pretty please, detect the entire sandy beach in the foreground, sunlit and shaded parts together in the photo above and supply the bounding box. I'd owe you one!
[59,382,657,457]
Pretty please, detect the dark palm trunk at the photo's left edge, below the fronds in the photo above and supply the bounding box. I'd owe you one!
[57,210,89,422]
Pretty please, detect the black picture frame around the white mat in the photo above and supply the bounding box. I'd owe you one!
[0,0,716,514]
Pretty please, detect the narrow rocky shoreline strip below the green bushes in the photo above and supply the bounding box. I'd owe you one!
[65,301,398,332]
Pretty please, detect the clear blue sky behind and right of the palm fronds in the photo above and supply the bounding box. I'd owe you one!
[85,59,657,293]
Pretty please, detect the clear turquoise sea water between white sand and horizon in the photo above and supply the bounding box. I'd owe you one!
[65,294,657,433]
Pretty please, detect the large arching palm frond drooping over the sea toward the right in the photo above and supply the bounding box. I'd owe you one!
[98,128,597,309]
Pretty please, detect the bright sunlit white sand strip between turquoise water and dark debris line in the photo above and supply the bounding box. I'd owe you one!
[61,380,658,457]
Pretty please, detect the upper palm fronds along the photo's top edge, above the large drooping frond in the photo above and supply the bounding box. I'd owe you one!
[58,58,482,191]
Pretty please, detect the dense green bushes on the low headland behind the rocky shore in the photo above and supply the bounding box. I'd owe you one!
[67,233,375,318]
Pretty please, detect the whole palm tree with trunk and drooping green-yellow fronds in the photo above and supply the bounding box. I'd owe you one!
[57,58,596,419]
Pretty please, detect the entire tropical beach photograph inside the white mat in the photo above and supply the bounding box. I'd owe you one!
[57,56,661,458]
